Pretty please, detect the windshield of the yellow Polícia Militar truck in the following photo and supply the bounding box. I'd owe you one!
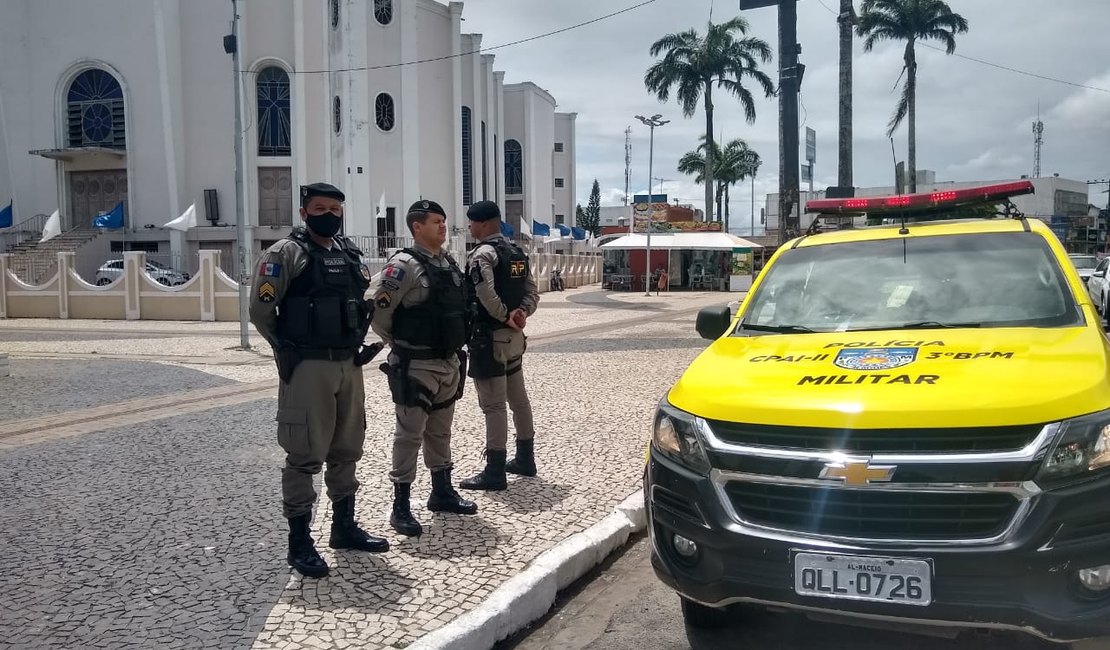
[734,233,1082,336]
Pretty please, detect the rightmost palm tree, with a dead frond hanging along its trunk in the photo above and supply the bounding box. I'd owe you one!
[858,0,968,193]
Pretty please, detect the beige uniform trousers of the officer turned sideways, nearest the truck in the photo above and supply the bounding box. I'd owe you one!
[474,327,536,451]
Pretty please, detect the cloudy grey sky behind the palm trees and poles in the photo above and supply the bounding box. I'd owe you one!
[452,0,1110,228]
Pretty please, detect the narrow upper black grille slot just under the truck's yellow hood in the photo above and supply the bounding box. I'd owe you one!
[709,420,1043,454]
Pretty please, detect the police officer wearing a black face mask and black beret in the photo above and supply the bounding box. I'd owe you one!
[250,183,390,578]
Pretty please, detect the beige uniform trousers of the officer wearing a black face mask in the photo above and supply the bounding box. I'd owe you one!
[278,359,366,517]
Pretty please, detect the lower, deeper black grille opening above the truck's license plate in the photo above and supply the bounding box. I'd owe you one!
[725,481,1019,540]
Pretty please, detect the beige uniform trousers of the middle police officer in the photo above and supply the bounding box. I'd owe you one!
[390,354,463,483]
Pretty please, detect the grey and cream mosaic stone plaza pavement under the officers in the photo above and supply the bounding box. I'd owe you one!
[0,288,730,649]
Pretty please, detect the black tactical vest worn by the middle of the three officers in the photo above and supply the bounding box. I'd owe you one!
[393,248,470,358]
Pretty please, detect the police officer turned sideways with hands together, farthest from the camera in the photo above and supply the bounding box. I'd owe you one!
[458,201,539,490]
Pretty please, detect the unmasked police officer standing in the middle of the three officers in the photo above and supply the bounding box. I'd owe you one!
[371,201,478,537]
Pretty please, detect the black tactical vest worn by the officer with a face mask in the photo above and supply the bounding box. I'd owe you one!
[278,228,370,349]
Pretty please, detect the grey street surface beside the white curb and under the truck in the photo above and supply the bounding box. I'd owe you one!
[496,535,1110,650]
